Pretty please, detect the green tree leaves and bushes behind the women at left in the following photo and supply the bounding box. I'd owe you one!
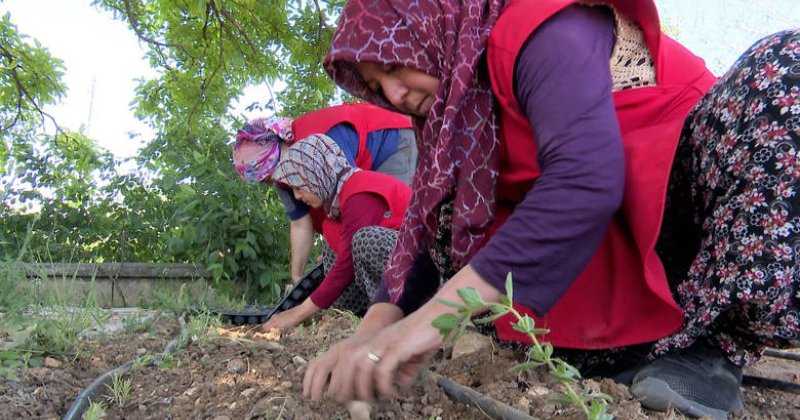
[0,0,356,302]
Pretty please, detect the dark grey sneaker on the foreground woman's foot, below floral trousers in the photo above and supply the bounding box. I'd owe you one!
[631,341,744,419]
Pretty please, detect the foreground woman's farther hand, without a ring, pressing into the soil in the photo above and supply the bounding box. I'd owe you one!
[303,303,403,400]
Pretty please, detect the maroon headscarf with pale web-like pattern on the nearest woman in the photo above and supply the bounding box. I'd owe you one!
[325,0,506,302]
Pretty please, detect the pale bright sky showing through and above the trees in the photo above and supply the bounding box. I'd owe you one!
[0,0,800,157]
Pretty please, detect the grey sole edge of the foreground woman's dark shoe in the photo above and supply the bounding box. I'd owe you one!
[631,377,743,420]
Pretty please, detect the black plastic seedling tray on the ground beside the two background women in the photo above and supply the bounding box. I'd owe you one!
[210,264,325,325]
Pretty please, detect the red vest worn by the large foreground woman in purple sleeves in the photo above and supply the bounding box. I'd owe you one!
[487,0,715,349]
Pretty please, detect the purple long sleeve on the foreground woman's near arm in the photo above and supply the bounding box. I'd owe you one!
[470,6,624,315]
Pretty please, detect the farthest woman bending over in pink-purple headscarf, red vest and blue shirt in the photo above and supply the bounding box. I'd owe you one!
[233,103,417,283]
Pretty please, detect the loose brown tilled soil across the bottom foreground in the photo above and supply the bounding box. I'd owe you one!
[0,312,800,420]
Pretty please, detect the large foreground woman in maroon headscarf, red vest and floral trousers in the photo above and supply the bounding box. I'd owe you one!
[304,0,800,417]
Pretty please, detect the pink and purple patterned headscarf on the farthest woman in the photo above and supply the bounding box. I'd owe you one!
[233,117,294,182]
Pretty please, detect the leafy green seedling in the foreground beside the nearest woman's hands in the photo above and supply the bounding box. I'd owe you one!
[433,273,612,420]
